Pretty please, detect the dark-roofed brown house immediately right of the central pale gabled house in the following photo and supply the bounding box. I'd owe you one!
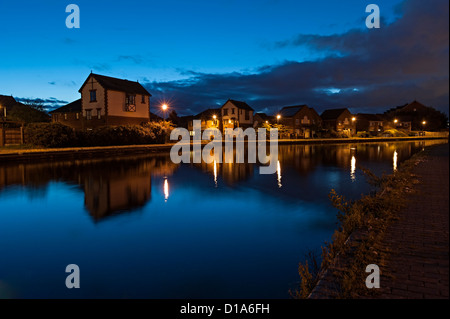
[278,105,321,138]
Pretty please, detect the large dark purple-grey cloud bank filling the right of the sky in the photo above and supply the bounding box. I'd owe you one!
[145,0,449,114]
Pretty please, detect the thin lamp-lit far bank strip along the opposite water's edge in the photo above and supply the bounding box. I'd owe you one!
[0,137,448,163]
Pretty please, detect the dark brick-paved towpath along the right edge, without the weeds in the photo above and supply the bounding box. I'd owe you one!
[380,144,449,299]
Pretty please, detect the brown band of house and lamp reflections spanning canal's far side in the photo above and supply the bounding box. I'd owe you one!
[0,140,442,221]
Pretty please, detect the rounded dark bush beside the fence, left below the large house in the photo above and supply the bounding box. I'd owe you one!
[25,123,76,147]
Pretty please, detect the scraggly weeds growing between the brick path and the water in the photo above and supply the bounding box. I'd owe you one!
[290,151,434,299]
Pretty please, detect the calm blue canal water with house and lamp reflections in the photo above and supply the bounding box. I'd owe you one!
[0,141,446,298]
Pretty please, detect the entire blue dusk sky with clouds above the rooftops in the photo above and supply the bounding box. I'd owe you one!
[0,0,449,115]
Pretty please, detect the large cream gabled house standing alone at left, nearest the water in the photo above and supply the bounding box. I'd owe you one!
[78,73,151,129]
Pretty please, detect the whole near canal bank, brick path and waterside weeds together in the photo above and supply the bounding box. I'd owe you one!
[309,144,449,299]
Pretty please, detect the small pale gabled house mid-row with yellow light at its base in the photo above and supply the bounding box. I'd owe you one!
[221,100,254,134]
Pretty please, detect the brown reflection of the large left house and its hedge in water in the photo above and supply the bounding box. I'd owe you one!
[0,156,177,221]
